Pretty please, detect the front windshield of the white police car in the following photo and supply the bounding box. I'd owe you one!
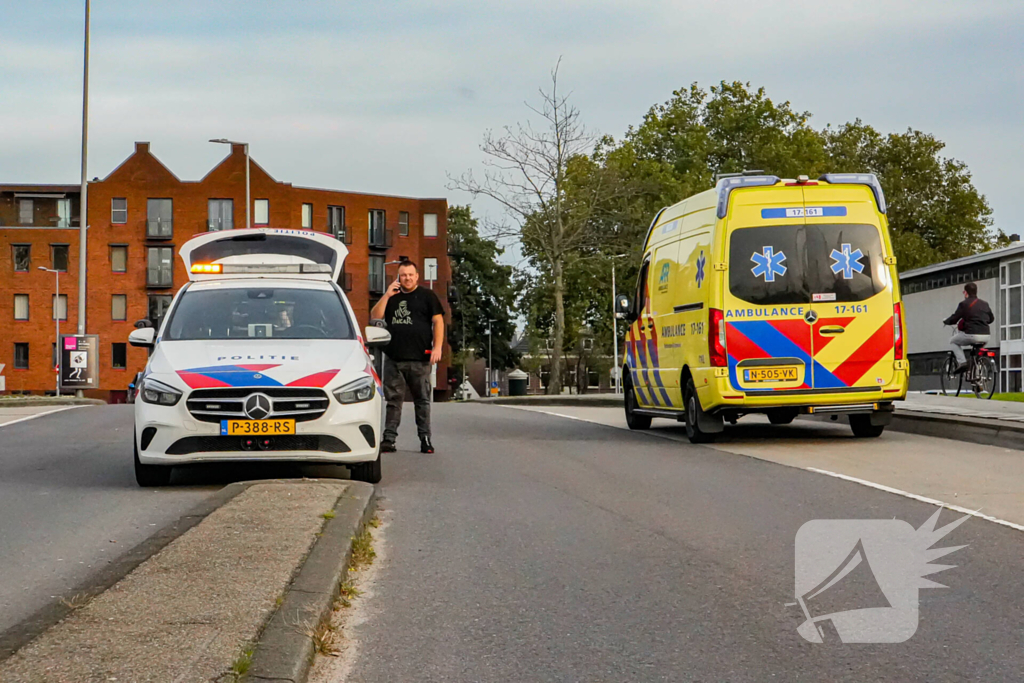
[164,288,355,341]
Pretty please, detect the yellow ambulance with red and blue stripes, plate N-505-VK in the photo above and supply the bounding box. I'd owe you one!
[618,171,909,443]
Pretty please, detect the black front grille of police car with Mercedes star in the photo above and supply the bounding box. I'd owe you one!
[185,387,331,422]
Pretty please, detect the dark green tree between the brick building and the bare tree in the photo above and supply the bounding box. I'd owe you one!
[447,206,518,382]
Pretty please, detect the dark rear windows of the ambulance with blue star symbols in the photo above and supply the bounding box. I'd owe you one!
[729,224,888,305]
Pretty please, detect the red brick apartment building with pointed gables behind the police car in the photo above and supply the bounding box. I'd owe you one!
[0,142,452,401]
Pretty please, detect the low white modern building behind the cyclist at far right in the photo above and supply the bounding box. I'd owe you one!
[899,236,1024,391]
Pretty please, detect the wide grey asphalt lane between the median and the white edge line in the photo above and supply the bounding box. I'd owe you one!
[349,404,1024,683]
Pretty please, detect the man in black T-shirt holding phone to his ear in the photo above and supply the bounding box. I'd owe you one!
[370,259,444,453]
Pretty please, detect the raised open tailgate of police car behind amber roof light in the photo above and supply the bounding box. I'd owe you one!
[179,227,348,282]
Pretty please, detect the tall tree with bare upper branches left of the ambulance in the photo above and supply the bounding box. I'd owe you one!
[449,59,602,393]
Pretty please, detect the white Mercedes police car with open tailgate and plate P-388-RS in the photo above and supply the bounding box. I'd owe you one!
[128,228,390,486]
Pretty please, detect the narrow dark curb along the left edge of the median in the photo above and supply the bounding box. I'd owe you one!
[0,481,249,661]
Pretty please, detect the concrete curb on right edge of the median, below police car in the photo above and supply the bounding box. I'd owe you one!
[242,481,377,683]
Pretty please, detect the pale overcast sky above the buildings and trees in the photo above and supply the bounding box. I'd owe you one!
[0,0,1024,245]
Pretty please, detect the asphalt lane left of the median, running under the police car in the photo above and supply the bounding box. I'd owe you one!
[0,405,345,634]
